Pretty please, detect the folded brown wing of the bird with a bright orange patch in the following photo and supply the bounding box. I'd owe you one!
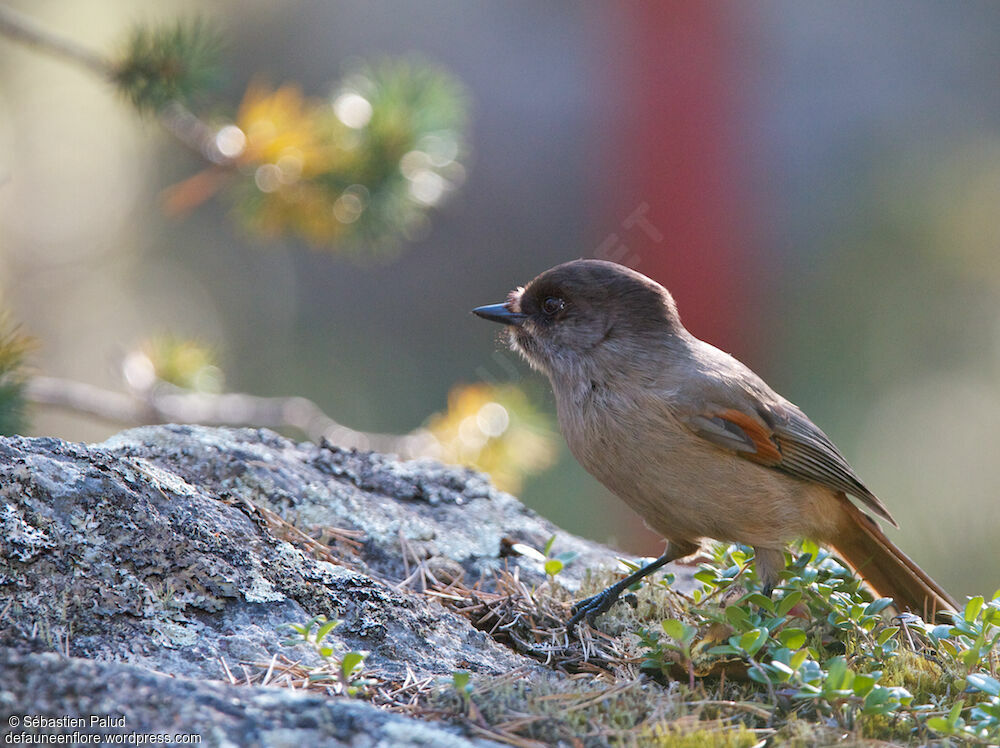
[682,406,898,527]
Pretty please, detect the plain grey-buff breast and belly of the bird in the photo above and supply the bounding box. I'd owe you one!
[556,385,833,545]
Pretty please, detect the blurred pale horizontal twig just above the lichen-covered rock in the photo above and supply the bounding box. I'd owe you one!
[25,376,434,459]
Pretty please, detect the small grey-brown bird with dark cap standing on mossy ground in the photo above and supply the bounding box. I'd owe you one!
[473,259,957,630]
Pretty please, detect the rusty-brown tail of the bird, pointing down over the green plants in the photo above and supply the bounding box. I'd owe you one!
[830,500,958,621]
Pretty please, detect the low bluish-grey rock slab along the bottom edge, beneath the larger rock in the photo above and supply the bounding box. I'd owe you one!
[0,650,498,748]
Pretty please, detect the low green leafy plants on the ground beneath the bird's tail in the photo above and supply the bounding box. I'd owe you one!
[640,545,1000,743]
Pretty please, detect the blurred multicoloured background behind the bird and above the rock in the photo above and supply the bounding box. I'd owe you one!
[0,0,1000,595]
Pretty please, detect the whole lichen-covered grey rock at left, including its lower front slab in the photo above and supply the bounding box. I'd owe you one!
[0,426,632,746]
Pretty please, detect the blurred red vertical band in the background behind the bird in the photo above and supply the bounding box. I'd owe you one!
[598,0,759,553]
